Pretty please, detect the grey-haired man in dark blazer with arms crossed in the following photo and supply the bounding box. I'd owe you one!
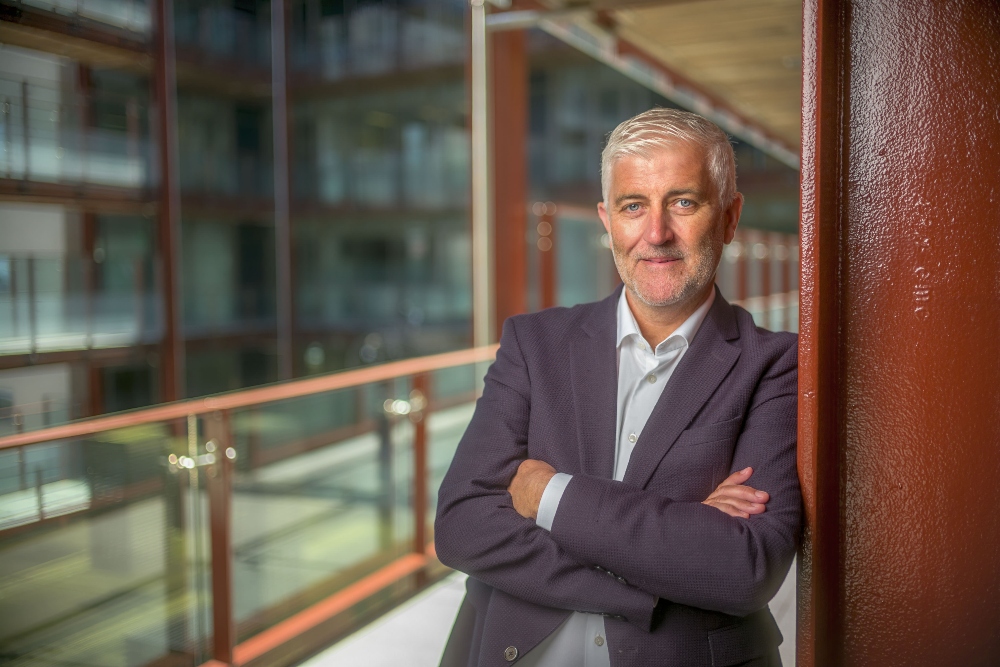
[435,109,801,667]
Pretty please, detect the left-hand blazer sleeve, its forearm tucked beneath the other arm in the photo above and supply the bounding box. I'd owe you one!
[434,319,657,630]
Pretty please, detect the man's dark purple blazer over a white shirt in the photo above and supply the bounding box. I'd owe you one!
[435,288,802,667]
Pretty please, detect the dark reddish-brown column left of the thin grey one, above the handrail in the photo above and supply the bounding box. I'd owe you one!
[153,0,184,401]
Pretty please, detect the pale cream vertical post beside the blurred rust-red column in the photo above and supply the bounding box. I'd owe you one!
[470,0,495,346]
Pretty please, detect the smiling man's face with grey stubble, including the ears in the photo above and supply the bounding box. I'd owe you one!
[597,143,743,307]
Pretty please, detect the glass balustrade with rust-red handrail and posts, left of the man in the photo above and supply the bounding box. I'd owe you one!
[0,349,493,667]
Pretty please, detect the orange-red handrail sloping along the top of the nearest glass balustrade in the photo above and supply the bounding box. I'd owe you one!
[0,345,499,451]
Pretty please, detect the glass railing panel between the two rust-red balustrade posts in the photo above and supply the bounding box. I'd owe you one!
[232,379,413,640]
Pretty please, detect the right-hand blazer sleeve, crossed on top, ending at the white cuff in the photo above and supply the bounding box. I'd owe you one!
[551,344,802,616]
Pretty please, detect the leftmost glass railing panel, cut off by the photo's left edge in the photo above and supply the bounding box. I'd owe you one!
[0,420,211,667]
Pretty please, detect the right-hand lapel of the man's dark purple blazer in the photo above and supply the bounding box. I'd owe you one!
[615,289,740,488]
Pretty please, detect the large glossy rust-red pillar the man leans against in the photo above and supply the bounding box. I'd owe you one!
[797,0,1000,667]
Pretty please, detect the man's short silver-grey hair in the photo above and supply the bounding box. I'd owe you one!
[601,108,736,207]
